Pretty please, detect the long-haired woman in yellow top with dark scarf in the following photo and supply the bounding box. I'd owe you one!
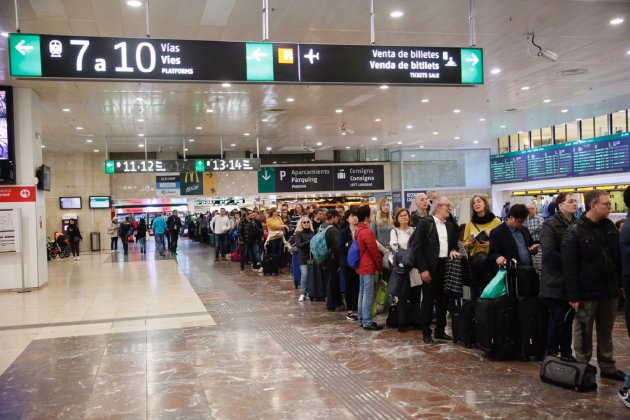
[464,194,501,293]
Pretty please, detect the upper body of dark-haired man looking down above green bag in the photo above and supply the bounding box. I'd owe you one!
[488,204,539,269]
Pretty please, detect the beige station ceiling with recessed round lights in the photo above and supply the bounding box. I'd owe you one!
[0,0,630,154]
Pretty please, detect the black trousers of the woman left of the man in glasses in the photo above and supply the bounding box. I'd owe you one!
[546,299,575,358]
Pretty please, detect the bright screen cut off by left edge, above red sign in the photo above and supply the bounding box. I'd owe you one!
[0,86,16,184]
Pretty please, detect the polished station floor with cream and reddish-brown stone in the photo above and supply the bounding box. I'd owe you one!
[0,240,630,419]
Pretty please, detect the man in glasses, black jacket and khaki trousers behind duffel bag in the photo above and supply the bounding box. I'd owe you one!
[561,190,624,381]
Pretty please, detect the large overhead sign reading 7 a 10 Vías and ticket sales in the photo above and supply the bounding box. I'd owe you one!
[9,34,483,85]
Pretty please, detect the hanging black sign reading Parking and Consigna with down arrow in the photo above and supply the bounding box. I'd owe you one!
[258,165,385,193]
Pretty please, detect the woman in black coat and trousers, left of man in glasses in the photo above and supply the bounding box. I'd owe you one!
[540,193,577,359]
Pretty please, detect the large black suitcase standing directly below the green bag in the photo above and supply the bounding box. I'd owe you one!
[474,296,519,360]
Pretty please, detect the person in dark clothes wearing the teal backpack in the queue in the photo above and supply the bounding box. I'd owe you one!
[320,209,343,311]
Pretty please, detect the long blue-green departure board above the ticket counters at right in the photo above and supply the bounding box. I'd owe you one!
[490,133,630,184]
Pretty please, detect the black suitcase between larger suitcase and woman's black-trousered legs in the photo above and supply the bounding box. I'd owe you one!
[518,296,548,360]
